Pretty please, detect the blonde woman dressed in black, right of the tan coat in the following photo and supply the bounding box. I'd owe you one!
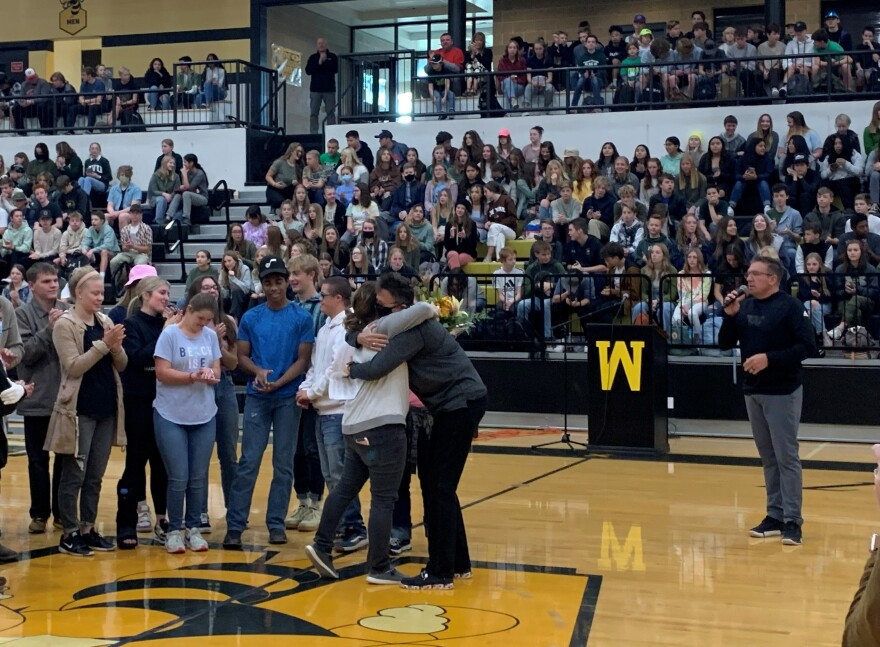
[116,276,174,549]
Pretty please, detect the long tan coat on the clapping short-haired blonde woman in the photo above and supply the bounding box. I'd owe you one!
[43,310,128,456]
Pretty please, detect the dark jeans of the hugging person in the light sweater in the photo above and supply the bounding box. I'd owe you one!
[315,425,406,573]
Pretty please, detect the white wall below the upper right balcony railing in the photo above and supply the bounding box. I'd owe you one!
[326,101,874,161]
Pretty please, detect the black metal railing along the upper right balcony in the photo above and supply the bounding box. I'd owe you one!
[337,50,880,123]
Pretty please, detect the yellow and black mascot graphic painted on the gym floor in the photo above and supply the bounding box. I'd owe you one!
[0,546,601,647]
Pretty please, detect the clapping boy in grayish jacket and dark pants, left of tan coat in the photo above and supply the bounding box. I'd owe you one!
[15,263,69,534]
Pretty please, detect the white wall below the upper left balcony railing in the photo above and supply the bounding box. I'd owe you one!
[0,128,246,191]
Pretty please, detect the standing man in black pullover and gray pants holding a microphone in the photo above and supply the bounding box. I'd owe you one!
[718,258,816,546]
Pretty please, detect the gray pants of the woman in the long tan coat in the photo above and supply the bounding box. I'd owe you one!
[58,416,116,534]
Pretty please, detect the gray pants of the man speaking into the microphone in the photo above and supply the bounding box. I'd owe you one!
[745,386,804,525]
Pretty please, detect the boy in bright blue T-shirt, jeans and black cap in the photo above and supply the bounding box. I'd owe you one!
[223,256,315,549]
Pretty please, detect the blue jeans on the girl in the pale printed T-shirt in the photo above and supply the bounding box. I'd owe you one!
[153,416,217,530]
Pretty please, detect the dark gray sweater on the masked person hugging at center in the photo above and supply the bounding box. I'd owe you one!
[347,319,487,413]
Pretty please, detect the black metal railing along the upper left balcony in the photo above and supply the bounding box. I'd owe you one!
[0,59,287,135]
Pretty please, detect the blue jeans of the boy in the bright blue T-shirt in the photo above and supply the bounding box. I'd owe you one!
[226,394,300,532]
